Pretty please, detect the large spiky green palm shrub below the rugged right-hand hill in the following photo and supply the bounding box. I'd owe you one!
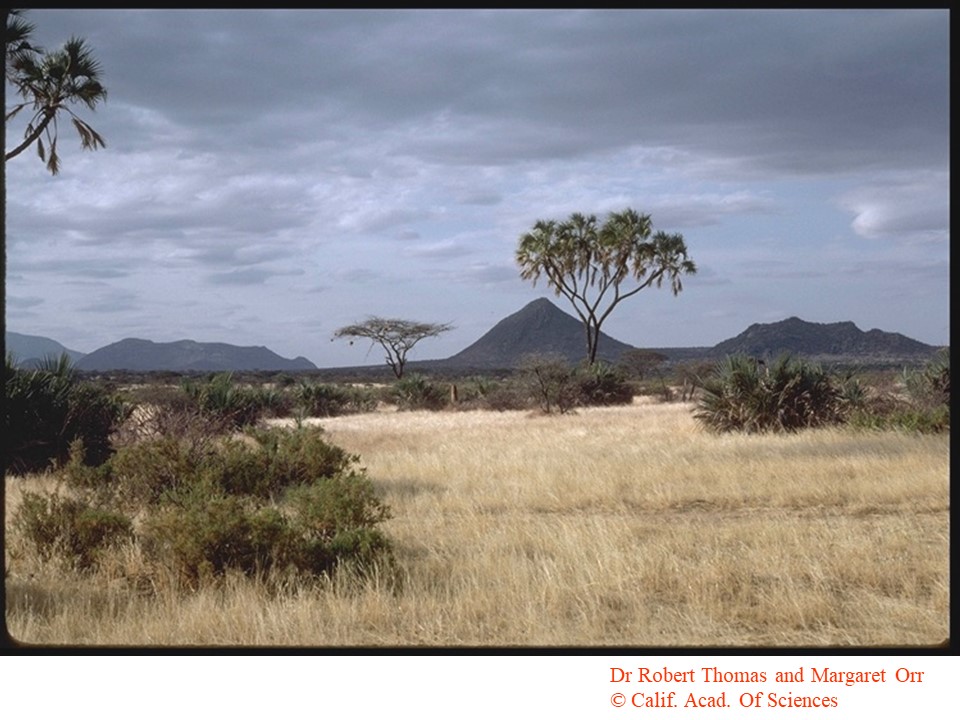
[694,354,843,432]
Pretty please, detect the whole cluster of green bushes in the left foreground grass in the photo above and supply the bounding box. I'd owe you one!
[15,428,391,587]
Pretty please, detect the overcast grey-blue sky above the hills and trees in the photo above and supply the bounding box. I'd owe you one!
[6,10,950,367]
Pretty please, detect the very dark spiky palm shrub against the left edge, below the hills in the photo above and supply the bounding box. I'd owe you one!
[3,355,131,473]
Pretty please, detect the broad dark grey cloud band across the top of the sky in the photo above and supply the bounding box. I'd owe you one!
[28,10,949,172]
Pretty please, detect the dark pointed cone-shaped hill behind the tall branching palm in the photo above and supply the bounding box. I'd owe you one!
[432,298,633,369]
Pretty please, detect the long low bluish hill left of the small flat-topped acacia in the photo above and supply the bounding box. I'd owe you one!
[77,338,317,372]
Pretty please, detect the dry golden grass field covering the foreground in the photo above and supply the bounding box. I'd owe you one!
[6,399,950,648]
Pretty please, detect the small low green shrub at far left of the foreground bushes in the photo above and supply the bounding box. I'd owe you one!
[13,492,133,570]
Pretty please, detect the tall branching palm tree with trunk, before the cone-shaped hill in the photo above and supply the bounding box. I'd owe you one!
[516,208,697,365]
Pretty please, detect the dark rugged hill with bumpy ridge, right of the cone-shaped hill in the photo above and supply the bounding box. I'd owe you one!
[711,317,936,359]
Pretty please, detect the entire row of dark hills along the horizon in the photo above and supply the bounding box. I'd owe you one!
[6,298,938,372]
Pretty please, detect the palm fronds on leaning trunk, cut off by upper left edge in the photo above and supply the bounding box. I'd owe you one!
[4,27,107,175]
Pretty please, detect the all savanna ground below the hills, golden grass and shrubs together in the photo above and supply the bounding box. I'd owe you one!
[4,352,950,646]
